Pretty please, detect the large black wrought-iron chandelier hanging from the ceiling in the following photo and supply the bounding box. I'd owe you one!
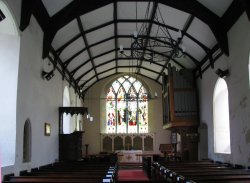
[119,2,186,63]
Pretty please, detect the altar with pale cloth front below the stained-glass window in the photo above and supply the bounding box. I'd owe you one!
[116,150,142,163]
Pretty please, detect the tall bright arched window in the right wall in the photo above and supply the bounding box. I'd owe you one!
[213,78,231,154]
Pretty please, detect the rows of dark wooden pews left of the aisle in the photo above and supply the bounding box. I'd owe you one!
[3,162,117,183]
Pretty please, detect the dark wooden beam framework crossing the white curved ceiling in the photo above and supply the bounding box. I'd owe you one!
[20,0,246,98]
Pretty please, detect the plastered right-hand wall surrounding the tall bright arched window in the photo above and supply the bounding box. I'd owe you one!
[197,13,250,166]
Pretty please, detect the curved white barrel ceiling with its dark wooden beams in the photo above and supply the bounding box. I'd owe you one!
[20,0,246,98]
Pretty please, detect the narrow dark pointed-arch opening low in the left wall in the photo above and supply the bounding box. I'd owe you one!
[23,119,31,162]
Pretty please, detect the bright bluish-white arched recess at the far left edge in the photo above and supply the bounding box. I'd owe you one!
[0,1,20,178]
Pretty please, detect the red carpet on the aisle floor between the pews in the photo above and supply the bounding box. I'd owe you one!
[118,169,150,183]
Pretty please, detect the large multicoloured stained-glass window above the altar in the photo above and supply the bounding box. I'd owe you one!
[106,75,148,133]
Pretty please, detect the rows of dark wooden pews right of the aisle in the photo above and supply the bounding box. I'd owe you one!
[152,162,250,183]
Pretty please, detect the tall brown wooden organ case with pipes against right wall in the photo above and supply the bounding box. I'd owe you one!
[162,65,199,160]
